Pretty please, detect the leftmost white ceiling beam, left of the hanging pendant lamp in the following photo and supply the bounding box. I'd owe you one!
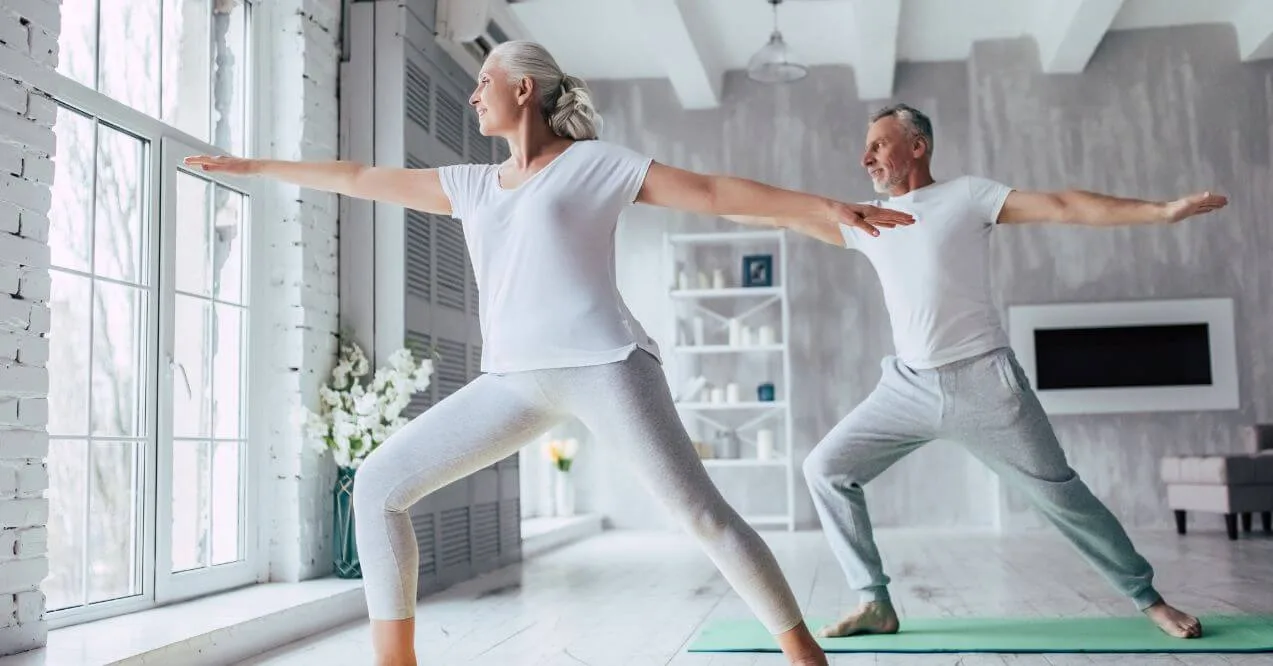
[629,0,724,108]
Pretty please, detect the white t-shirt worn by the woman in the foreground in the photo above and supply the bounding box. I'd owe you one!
[438,140,659,373]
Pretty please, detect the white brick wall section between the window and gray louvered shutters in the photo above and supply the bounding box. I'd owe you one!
[262,0,340,581]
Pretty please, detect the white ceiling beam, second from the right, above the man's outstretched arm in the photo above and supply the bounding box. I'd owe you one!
[1034,0,1123,74]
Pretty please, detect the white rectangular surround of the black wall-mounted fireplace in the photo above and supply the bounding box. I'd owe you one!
[1007,298,1239,414]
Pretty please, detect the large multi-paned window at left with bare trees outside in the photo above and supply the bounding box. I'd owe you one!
[43,0,258,624]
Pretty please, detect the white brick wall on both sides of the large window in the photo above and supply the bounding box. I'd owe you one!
[0,0,340,655]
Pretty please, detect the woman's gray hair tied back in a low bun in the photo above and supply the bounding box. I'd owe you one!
[490,39,601,140]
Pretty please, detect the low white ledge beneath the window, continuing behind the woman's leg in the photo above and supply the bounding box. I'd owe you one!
[0,514,602,666]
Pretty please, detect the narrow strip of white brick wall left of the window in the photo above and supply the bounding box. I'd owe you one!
[0,0,61,655]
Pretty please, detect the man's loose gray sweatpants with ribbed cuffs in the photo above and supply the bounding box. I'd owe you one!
[805,349,1161,610]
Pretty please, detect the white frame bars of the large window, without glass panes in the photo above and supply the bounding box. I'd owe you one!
[14,0,272,629]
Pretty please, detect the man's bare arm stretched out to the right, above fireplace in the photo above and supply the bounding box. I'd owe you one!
[998,190,1228,227]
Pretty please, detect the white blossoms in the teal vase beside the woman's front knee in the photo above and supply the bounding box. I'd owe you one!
[306,343,433,470]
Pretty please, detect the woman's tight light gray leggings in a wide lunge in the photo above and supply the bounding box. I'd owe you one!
[354,351,801,634]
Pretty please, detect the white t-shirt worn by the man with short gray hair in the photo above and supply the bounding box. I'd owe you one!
[841,176,1012,369]
